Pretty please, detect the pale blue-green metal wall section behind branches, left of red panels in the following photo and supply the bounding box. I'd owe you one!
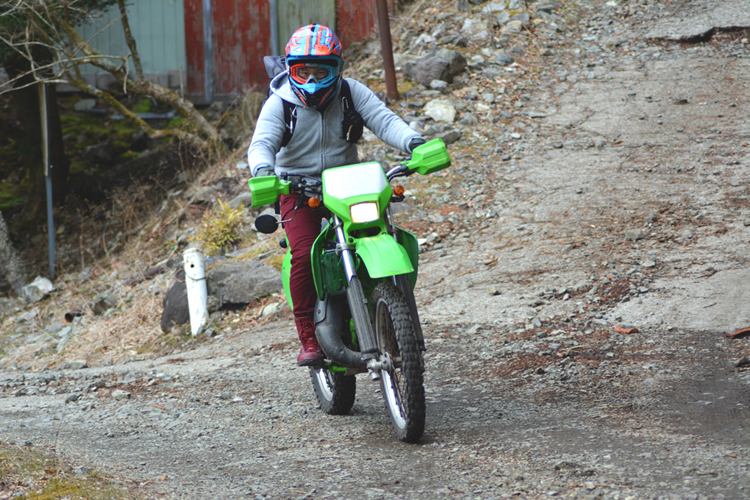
[77,0,187,87]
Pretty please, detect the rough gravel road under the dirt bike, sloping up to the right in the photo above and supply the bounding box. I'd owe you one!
[0,0,750,499]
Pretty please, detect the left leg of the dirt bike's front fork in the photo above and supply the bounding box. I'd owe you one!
[333,215,385,380]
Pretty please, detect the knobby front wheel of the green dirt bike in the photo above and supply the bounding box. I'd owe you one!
[372,283,425,443]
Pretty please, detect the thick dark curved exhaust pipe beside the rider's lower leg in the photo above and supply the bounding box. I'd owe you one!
[315,295,368,369]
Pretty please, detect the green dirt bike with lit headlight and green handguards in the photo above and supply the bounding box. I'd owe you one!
[249,139,451,443]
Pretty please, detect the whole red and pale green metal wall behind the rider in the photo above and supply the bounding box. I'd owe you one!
[73,0,395,103]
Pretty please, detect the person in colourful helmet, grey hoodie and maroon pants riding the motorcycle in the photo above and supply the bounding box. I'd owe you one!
[247,24,425,366]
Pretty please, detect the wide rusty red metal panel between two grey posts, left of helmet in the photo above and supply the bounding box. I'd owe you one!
[213,0,271,96]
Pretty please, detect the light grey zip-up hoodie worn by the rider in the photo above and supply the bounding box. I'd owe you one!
[247,72,421,176]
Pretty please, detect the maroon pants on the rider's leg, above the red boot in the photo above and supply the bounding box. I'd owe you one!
[280,195,323,319]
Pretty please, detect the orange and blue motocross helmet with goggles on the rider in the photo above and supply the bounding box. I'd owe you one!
[285,24,344,109]
